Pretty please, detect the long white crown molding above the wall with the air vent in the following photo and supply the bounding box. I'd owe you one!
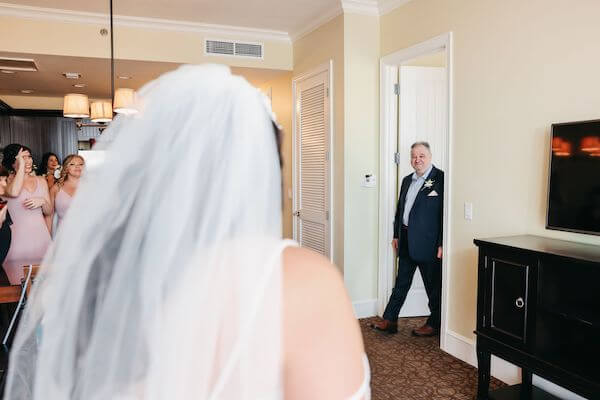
[0,3,291,43]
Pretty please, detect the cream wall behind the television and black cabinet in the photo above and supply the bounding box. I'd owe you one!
[381,0,600,337]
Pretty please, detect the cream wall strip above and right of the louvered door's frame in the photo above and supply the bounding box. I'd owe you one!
[294,15,344,270]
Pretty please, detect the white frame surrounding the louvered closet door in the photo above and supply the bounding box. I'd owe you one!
[292,60,335,263]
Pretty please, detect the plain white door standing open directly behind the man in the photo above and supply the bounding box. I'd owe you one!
[396,66,448,317]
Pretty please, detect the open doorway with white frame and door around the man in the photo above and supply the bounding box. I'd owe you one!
[378,33,452,349]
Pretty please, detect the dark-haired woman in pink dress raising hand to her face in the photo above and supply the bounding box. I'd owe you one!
[2,144,52,285]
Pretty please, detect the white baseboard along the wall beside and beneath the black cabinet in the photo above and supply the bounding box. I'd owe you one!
[442,330,585,400]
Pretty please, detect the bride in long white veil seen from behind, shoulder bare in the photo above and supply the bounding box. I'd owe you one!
[6,65,369,400]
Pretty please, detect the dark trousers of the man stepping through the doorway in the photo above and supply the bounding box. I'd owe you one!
[383,227,442,329]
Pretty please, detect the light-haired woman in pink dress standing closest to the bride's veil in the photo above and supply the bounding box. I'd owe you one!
[50,154,85,231]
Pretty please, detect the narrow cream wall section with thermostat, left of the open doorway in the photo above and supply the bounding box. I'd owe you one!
[344,14,379,302]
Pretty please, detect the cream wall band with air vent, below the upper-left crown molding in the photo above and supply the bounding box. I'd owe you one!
[0,16,292,70]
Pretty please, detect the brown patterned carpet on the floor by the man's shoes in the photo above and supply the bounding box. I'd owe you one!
[360,318,504,400]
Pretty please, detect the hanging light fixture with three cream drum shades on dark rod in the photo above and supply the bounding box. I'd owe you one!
[63,0,137,130]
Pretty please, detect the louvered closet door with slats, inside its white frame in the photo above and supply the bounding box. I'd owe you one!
[294,70,331,258]
